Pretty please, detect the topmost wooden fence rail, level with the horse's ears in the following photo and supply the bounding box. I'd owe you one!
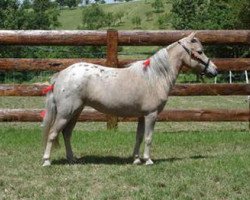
[0,30,250,46]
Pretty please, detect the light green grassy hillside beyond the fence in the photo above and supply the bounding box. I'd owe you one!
[58,0,171,30]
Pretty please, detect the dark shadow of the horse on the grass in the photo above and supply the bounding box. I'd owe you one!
[52,155,211,165]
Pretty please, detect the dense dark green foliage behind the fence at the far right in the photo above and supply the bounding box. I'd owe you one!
[171,0,250,57]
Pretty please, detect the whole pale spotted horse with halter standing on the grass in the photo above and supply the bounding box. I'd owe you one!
[43,33,217,166]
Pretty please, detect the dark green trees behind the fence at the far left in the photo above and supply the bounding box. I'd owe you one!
[0,0,59,82]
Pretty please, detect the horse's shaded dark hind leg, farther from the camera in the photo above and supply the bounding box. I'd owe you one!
[62,109,82,163]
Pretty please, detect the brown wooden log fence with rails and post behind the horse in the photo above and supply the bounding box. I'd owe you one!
[0,30,250,127]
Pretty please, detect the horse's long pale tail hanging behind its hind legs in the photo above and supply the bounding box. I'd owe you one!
[43,74,59,146]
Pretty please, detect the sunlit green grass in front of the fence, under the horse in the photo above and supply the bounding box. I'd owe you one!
[0,126,250,199]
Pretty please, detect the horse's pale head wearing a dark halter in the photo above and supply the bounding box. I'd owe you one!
[178,32,218,77]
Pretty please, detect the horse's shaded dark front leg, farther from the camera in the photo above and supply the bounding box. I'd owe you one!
[133,117,145,165]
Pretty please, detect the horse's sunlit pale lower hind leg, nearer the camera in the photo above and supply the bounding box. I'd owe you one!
[43,115,69,166]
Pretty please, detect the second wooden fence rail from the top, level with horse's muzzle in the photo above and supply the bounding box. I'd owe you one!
[0,58,250,72]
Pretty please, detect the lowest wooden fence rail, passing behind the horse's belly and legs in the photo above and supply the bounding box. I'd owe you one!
[0,109,249,122]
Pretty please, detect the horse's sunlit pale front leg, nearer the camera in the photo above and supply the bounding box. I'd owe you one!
[143,112,158,165]
